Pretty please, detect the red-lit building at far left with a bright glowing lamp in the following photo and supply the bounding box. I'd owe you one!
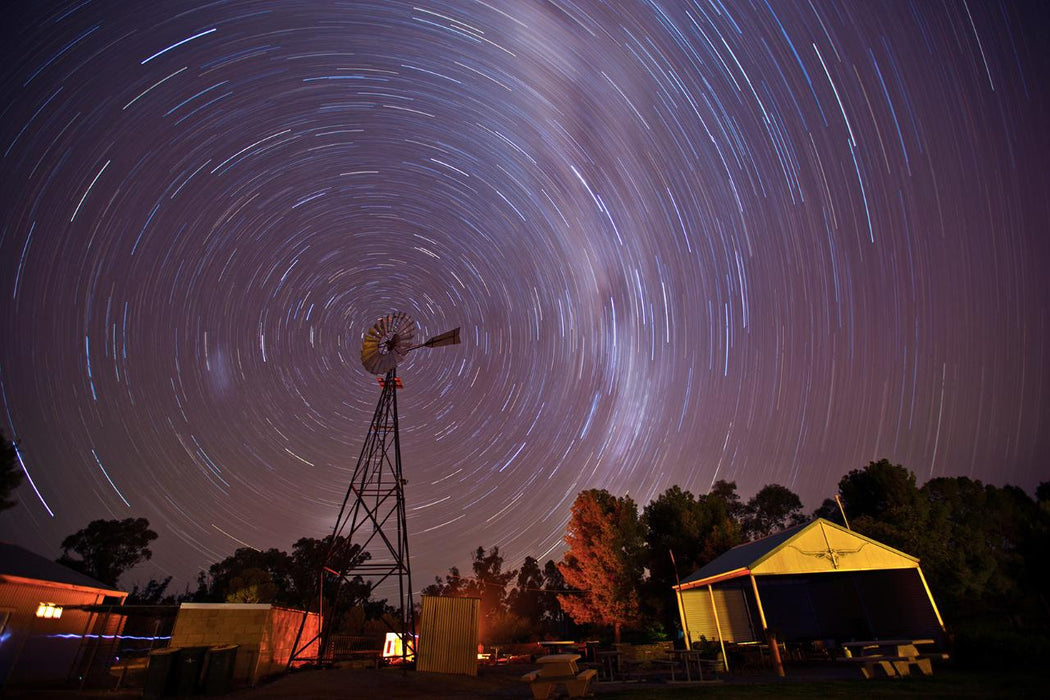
[0,543,127,688]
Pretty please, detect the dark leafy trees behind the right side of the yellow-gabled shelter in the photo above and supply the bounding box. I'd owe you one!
[839,460,1050,630]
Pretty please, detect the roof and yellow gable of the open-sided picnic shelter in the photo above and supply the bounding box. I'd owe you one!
[675,517,919,591]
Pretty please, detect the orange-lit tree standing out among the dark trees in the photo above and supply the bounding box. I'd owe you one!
[558,489,645,642]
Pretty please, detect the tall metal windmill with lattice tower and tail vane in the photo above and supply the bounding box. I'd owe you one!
[289,313,460,664]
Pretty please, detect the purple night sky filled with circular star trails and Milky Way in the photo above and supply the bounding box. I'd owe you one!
[0,0,1050,589]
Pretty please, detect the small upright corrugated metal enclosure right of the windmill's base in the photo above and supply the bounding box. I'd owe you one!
[416,595,481,676]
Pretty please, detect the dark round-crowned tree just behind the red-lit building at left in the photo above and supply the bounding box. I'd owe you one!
[58,517,156,587]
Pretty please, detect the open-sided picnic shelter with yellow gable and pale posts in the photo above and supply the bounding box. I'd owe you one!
[674,518,944,645]
